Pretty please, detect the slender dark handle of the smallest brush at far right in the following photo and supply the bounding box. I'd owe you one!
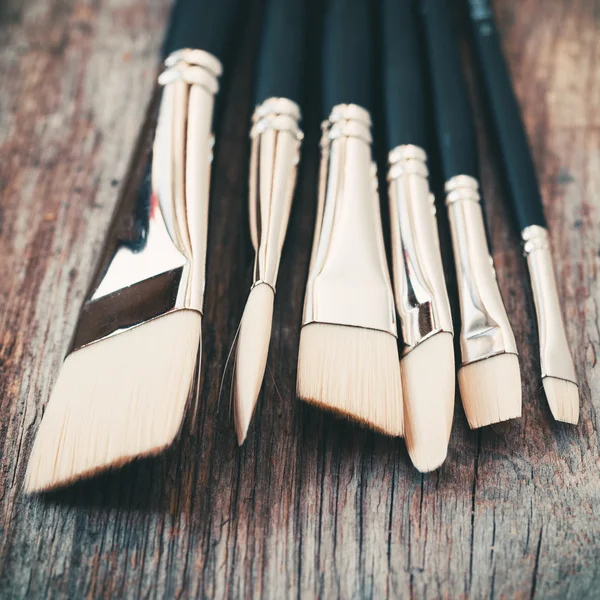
[469,0,546,231]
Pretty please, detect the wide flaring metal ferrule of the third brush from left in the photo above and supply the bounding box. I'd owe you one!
[303,104,397,336]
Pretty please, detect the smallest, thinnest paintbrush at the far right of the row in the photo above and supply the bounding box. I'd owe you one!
[469,0,579,424]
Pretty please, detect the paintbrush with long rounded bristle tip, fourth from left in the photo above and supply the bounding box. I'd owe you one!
[380,0,455,472]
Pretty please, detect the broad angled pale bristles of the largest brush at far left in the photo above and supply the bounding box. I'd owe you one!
[25,310,202,492]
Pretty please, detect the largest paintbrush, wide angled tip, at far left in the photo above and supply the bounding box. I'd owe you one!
[25,0,240,492]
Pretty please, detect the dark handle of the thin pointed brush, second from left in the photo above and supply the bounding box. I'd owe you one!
[255,0,308,105]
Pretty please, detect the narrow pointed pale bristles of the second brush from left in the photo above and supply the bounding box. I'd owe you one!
[234,284,275,446]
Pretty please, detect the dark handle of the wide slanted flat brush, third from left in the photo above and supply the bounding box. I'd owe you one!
[323,0,373,115]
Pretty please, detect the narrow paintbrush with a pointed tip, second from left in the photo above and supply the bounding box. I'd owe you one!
[234,0,308,445]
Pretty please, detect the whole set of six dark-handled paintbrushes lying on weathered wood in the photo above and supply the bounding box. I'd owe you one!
[26,0,579,491]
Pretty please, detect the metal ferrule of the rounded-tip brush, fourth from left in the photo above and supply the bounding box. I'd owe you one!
[388,145,454,354]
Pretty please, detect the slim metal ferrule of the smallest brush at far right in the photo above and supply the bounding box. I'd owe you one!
[521,225,577,385]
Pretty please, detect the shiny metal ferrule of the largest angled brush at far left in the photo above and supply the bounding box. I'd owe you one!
[72,49,221,350]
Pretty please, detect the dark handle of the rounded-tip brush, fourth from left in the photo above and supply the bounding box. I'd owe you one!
[380,0,427,149]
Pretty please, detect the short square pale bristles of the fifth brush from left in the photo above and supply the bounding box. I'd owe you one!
[458,353,521,429]
